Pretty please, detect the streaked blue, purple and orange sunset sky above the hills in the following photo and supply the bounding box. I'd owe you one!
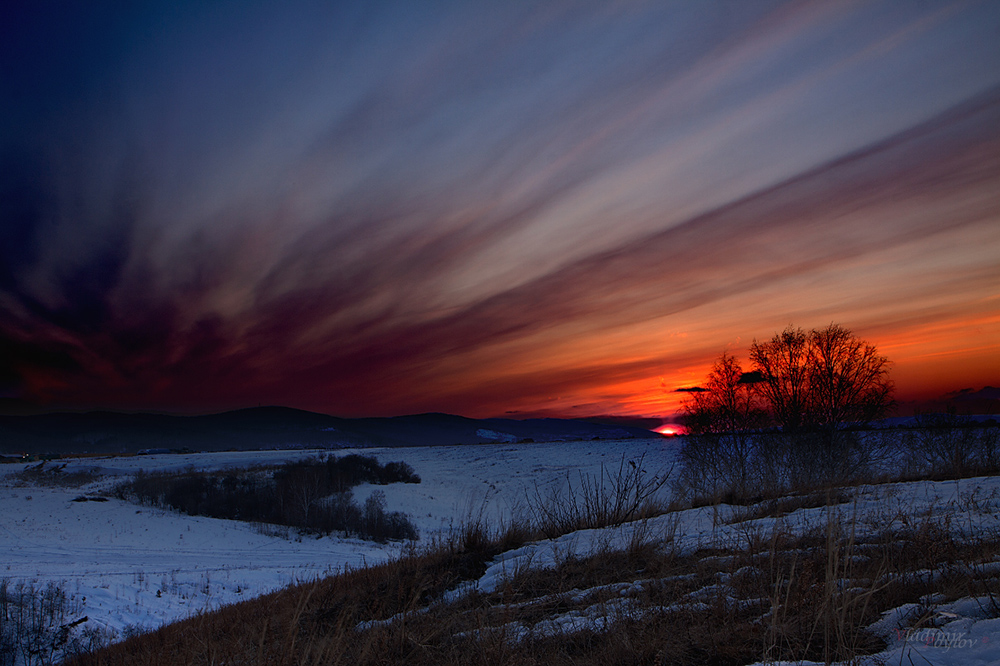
[0,0,1000,417]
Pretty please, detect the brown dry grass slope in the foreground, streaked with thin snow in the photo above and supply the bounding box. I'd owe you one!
[68,482,1000,666]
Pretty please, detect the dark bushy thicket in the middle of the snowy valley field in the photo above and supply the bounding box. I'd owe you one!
[116,454,420,541]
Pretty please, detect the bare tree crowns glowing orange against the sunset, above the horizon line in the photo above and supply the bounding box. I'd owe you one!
[685,324,894,434]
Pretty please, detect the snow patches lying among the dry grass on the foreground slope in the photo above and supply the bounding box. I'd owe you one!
[444,470,1000,666]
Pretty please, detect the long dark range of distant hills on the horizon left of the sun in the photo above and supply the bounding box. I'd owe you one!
[0,407,657,455]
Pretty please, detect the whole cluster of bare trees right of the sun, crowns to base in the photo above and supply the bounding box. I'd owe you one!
[677,324,894,502]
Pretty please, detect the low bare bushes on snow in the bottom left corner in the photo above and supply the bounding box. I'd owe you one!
[0,579,110,666]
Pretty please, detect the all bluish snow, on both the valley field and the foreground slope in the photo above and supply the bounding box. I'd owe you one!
[0,438,1000,664]
